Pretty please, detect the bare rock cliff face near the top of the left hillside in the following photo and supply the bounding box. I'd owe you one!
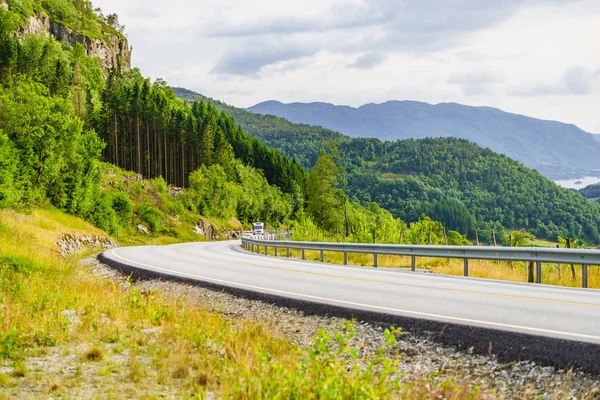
[19,14,131,73]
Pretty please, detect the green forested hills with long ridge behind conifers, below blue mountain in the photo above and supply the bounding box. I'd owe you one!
[175,89,600,243]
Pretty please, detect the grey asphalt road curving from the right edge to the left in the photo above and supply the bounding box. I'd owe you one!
[100,241,600,372]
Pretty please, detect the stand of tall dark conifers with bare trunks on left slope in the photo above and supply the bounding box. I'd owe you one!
[97,73,304,197]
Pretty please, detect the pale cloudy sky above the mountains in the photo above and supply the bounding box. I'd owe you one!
[93,0,600,133]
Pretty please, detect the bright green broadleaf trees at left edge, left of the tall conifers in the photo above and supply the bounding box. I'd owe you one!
[0,75,102,215]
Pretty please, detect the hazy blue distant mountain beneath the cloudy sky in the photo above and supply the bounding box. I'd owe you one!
[248,101,600,179]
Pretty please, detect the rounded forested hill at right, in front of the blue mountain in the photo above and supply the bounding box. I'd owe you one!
[342,138,600,243]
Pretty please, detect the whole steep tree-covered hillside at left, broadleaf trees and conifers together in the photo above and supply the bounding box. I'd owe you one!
[0,0,305,232]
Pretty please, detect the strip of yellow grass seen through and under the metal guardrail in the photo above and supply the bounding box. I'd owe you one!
[261,247,600,289]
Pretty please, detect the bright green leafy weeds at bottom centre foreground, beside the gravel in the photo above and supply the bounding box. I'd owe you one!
[237,322,400,399]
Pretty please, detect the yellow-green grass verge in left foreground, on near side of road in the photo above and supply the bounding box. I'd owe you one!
[0,210,510,399]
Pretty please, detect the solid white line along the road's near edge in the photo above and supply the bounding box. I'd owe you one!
[110,249,600,341]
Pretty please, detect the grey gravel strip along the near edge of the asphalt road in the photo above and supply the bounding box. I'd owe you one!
[82,257,600,399]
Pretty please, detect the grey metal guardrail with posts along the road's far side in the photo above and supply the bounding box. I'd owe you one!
[242,237,600,288]
